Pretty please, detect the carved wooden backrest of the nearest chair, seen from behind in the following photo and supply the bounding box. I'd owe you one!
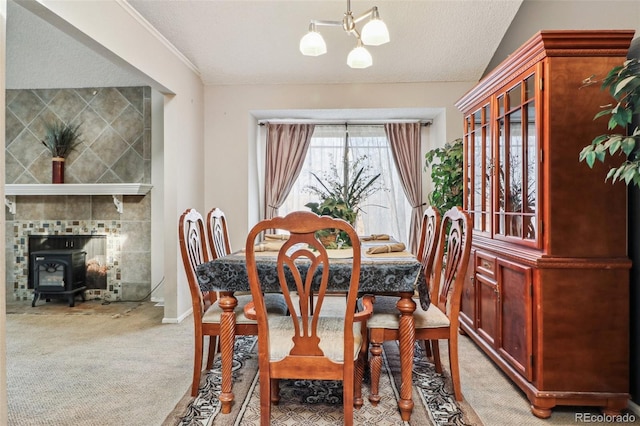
[246,211,361,368]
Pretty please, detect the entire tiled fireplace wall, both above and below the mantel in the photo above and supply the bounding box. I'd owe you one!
[4,87,152,301]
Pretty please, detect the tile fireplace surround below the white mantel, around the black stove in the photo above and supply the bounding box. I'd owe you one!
[6,195,151,301]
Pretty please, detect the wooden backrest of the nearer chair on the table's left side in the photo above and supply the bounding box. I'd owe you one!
[178,209,210,326]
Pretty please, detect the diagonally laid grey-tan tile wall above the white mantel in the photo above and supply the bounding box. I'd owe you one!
[5,87,151,183]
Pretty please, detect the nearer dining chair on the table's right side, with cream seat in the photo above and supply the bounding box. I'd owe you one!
[367,207,471,405]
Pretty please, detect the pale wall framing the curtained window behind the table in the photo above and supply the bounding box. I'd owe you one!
[204,82,474,249]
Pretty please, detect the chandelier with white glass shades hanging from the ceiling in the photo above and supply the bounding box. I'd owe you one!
[300,0,389,68]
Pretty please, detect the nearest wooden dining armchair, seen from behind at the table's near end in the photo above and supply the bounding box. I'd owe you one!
[245,211,373,426]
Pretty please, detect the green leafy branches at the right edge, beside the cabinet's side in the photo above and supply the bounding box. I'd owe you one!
[579,59,640,187]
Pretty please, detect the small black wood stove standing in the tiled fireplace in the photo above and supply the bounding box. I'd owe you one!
[29,249,87,307]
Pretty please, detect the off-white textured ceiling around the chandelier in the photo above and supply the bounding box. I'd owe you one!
[129,0,522,85]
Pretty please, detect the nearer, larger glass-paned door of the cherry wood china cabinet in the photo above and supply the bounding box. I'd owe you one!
[494,70,538,244]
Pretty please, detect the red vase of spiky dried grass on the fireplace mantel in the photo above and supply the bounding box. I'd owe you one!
[42,122,81,183]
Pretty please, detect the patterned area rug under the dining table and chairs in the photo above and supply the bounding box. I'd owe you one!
[163,336,482,426]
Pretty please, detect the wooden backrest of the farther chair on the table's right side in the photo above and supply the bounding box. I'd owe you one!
[417,206,440,306]
